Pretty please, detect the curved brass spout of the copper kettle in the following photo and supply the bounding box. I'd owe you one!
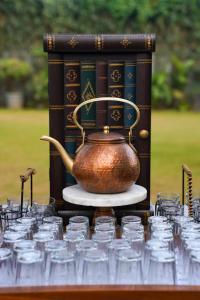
[40,135,74,175]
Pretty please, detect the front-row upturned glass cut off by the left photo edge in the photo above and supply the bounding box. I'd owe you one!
[0,248,13,286]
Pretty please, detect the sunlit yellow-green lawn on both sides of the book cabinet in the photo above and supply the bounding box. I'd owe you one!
[0,110,200,200]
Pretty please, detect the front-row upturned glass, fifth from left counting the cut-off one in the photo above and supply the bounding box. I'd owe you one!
[115,249,143,284]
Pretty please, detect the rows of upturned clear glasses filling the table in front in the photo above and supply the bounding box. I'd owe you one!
[0,211,200,285]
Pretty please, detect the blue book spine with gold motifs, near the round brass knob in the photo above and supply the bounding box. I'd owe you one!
[124,61,136,128]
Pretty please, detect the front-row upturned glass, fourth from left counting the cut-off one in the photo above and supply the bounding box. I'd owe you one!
[82,249,109,284]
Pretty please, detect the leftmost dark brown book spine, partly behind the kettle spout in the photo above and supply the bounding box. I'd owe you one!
[48,53,65,208]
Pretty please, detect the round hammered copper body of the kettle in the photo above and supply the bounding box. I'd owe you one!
[72,133,140,194]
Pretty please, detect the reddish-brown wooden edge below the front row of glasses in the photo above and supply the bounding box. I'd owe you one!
[0,285,200,300]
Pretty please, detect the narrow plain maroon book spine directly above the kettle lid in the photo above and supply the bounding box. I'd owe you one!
[96,61,108,128]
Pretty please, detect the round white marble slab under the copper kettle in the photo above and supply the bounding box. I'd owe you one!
[63,184,147,207]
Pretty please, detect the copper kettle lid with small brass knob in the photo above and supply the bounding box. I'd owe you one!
[87,126,126,144]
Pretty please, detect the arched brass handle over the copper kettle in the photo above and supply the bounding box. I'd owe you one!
[73,97,140,151]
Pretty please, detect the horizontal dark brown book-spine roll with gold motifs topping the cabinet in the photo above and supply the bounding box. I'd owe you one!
[43,33,156,53]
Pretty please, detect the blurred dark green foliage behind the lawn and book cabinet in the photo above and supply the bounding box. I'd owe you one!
[0,0,200,110]
